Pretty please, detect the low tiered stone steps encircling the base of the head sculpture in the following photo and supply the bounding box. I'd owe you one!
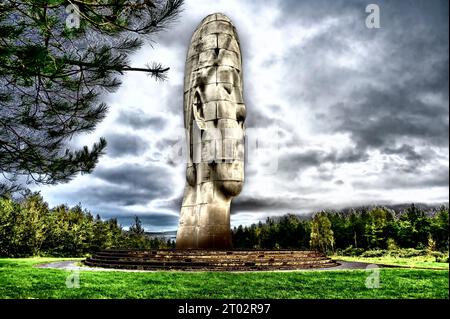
[84,250,337,271]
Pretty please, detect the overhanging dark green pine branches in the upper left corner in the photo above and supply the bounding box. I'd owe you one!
[0,0,183,194]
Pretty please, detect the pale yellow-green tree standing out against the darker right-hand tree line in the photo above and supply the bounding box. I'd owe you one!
[310,212,334,253]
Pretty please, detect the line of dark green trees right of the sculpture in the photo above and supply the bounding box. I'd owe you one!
[233,204,449,252]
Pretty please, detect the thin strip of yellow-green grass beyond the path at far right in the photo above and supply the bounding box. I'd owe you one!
[331,256,448,269]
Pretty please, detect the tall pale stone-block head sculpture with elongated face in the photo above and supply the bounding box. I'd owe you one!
[176,13,246,249]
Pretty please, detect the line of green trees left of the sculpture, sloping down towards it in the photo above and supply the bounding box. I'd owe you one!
[0,193,175,257]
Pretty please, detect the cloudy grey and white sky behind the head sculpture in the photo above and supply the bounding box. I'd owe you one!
[40,0,449,231]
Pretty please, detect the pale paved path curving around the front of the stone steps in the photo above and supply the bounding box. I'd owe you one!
[35,260,380,272]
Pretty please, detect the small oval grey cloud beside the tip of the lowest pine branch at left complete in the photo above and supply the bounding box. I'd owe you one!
[106,133,148,157]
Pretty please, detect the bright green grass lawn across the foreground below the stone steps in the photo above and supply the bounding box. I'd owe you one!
[0,258,449,299]
